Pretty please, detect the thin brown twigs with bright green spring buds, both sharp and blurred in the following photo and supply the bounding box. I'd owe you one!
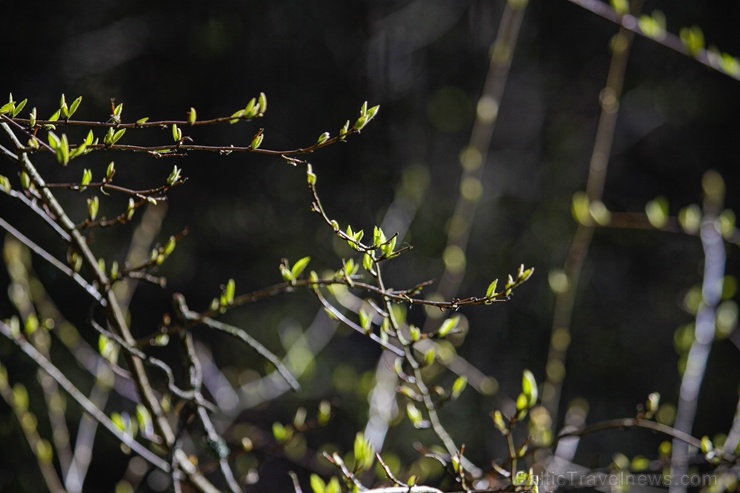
[0,4,740,493]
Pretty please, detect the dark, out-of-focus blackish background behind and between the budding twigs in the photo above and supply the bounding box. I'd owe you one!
[0,0,740,492]
